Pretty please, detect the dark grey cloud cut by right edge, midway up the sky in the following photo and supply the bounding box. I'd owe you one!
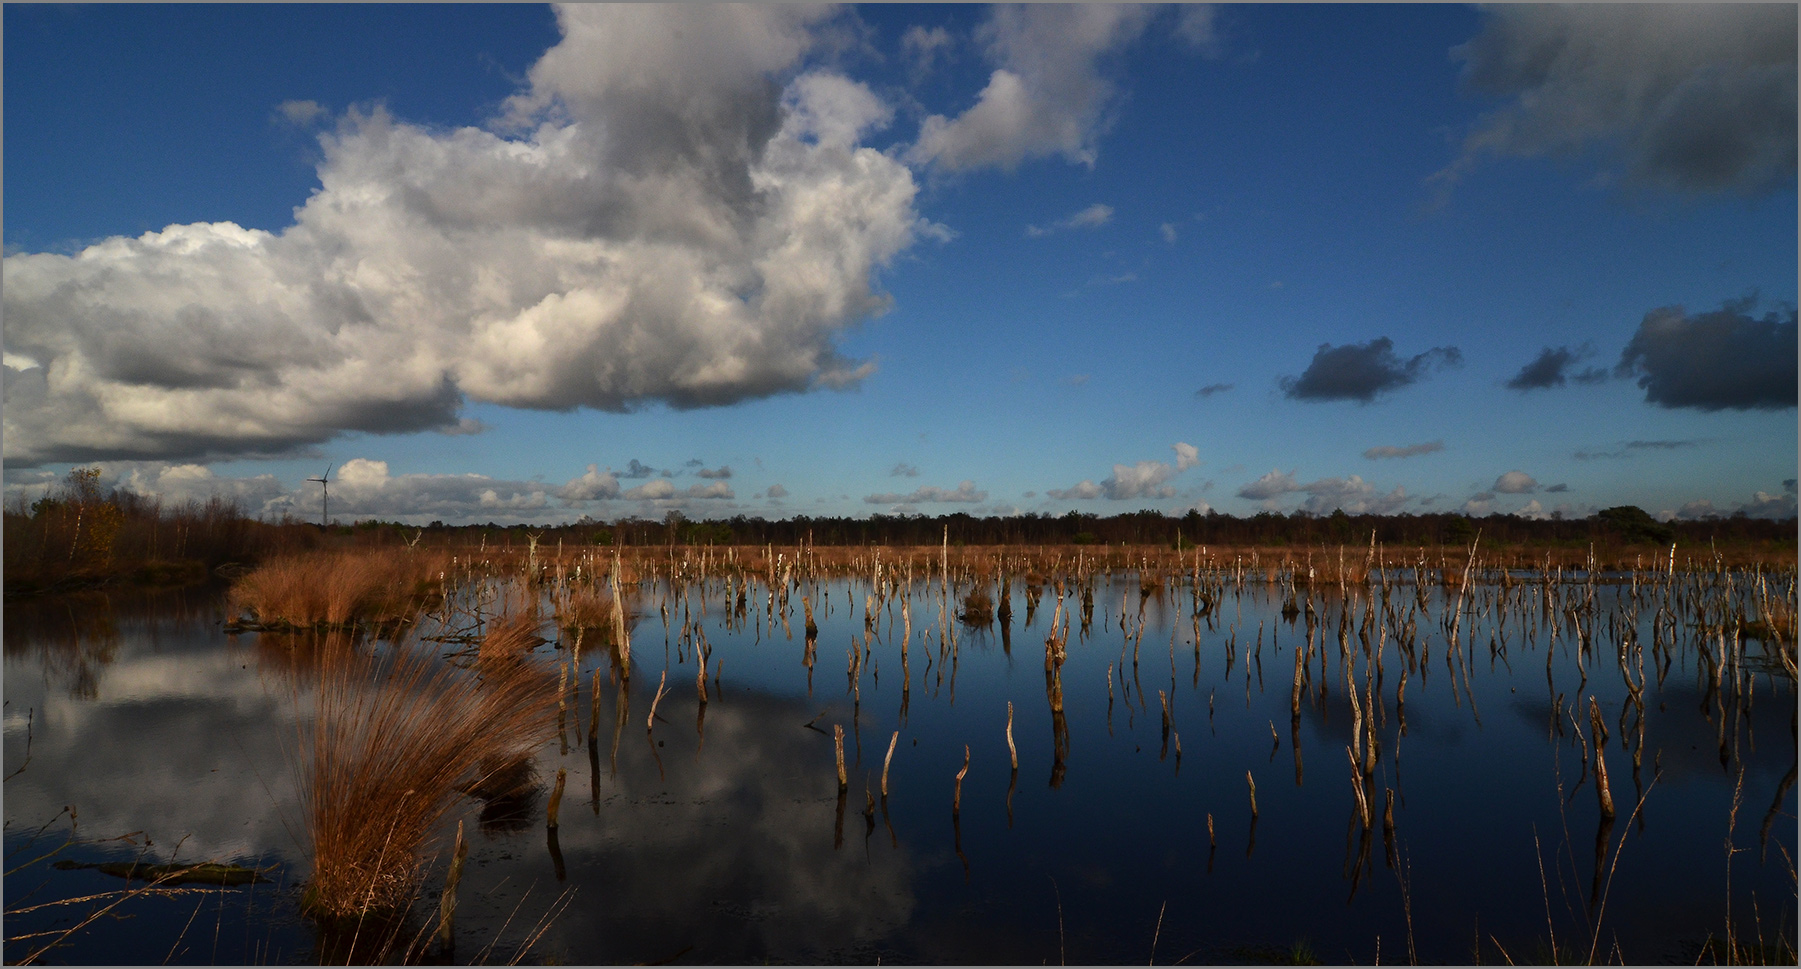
[1614,297,1797,411]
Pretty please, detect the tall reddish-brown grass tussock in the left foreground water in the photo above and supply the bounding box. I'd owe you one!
[301,630,557,919]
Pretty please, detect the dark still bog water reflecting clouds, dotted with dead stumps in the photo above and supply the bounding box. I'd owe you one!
[5,575,1796,964]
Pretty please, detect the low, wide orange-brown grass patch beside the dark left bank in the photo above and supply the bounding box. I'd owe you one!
[231,549,436,629]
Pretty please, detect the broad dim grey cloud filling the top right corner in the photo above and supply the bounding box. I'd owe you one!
[1434,4,1796,195]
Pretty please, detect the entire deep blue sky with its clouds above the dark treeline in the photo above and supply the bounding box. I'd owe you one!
[5,5,1797,522]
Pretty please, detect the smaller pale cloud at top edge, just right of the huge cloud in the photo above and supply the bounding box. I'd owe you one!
[908,4,1159,171]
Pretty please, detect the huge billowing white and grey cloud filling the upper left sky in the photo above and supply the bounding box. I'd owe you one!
[4,5,920,466]
